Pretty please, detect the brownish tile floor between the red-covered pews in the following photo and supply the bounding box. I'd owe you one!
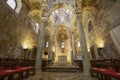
[26,72,97,80]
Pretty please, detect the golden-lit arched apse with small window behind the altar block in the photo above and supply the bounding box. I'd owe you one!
[54,25,71,63]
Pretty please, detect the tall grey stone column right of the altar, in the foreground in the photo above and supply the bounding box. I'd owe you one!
[77,17,91,74]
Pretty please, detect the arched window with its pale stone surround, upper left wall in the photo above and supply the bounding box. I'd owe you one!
[7,0,22,14]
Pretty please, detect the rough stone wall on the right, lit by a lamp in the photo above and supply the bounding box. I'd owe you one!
[82,0,120,58]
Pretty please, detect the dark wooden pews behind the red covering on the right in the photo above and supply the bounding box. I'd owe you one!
[74,59,120,72]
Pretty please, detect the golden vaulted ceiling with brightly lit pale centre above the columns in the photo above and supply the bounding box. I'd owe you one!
[24,0,104,40]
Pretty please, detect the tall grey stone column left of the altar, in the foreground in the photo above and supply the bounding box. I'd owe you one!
[35,22,47,71]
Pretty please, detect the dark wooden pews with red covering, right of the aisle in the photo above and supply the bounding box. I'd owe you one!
[90,59,120,80]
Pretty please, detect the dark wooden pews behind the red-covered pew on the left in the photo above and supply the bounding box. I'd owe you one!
[0,58,35,69]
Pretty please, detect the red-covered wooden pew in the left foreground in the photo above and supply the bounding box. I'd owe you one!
[0,66,35,80]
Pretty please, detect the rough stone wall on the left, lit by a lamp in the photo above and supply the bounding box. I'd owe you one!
[0,0,37,58]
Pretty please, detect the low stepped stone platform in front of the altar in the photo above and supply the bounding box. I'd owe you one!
[46,64,80,72]
